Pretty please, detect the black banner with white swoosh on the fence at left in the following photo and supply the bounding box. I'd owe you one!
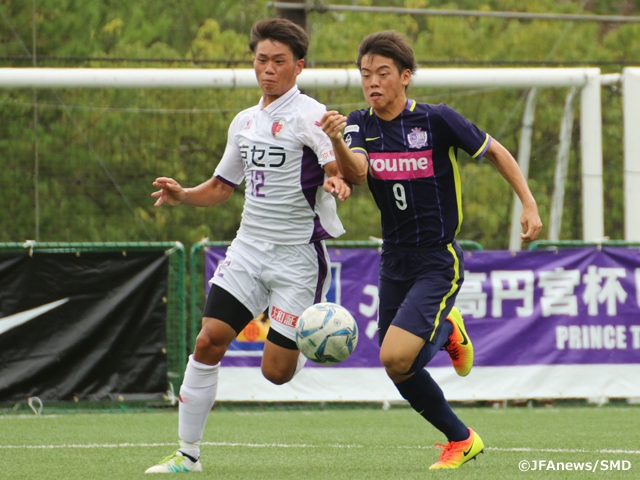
[0,251,169,402]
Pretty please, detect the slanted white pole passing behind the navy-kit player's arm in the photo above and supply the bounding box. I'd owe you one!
[509,87,538,251]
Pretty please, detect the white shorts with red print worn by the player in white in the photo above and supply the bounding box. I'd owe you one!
[209,237,331,341]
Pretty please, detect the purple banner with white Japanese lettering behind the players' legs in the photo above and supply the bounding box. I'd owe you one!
[205,247,640,367]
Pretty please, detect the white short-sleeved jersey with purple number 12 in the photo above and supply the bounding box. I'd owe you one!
[214,86,344,245]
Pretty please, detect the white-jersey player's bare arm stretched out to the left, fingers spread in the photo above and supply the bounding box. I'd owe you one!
[151,177,233,207]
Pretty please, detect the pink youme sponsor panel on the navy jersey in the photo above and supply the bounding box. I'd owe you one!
[369,150,433,180]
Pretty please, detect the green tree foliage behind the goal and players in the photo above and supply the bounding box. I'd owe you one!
[0,0,640,248]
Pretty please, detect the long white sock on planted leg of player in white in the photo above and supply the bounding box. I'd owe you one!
[178,355,219,458]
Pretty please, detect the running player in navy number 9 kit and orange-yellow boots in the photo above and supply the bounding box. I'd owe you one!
[322,31,542,469]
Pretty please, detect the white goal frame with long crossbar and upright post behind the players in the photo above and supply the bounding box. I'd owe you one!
[0,68,624,241]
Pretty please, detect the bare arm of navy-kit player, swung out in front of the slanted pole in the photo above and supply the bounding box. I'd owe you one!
[484,138,542,243]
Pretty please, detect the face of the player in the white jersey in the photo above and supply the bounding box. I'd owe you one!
[253,40,304,106]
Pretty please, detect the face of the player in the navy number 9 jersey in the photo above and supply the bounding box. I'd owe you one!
[360,55,411,120]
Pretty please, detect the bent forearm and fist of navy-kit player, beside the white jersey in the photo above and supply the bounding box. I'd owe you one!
[321,110,368,185]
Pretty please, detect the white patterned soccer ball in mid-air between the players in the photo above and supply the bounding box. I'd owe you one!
[296,302,358,365]
